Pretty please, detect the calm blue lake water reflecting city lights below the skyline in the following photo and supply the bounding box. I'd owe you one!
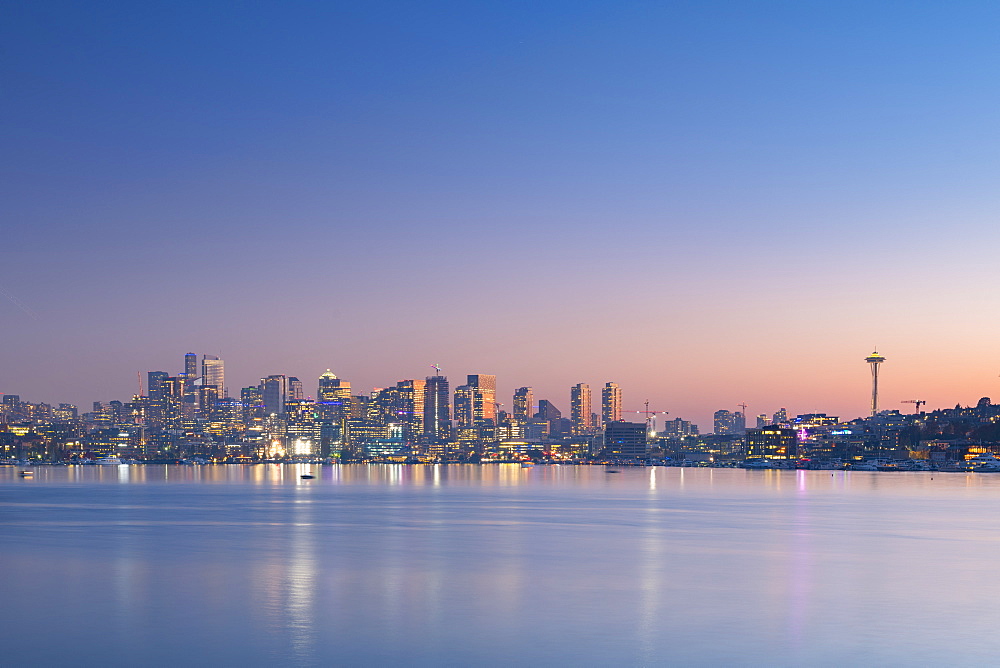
[0,465,1000,666]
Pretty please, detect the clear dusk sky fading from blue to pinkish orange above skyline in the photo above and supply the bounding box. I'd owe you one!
[0,0,1000,431]
